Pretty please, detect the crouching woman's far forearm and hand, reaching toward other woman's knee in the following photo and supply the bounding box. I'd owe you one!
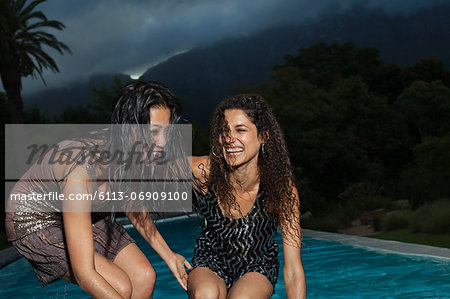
[127,212,192,290]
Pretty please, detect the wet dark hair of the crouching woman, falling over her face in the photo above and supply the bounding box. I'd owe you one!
[107,81,190,221]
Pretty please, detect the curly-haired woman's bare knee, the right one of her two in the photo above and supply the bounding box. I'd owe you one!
[228,272,273,299]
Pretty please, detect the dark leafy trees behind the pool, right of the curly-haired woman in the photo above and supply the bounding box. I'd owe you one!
[238,42,450,227]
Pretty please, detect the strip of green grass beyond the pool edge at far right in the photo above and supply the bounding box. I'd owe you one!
[369,228,450,248]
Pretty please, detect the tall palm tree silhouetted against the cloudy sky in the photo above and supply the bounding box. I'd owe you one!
[0,0,71,123]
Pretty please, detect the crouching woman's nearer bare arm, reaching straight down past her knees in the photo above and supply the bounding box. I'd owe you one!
[62,166,122,298]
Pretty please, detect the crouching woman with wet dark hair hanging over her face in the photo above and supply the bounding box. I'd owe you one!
[6,82,190,298]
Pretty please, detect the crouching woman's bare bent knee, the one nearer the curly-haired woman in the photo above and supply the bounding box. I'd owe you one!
[114,243,156,299]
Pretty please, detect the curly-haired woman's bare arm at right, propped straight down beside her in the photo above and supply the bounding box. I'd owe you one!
[282,187,306,299]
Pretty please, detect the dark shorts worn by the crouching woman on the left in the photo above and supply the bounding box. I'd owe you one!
[13,217,135,286]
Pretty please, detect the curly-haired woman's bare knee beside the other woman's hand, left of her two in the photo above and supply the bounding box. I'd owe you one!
[188,267,227,299]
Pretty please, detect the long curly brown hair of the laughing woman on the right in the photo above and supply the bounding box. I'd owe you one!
[204,94,300,244]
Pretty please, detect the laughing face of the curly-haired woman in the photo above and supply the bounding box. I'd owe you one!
[223,109,263,167]
